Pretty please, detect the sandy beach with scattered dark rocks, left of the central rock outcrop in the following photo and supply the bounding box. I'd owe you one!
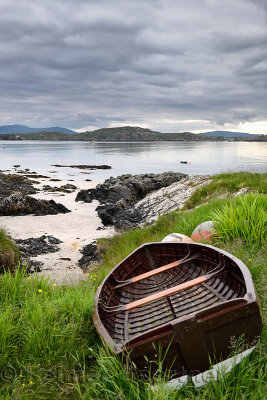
[0,170,114,283]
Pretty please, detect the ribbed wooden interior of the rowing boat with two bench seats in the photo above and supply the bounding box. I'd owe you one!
[98,243,246,344]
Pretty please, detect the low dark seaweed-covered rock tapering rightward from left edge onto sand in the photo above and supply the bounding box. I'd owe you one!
[0,192,70,215]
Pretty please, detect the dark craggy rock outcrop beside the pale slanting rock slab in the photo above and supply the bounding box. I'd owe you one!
[76,172,187,229]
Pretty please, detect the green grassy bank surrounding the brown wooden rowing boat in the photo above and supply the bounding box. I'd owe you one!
[0,191,267,400]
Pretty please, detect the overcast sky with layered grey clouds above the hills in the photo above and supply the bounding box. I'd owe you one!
[0,0,267,133]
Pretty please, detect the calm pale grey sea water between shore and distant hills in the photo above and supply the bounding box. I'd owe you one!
[0,141,267,182]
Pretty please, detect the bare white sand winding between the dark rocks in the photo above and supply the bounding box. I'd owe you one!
[0,177,114,283]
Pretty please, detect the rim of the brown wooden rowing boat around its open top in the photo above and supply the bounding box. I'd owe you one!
[92,242,257,354]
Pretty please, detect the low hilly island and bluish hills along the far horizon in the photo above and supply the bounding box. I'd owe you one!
[0,125,267,142]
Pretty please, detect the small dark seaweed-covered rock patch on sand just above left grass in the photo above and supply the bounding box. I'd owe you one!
[16,235,62,259]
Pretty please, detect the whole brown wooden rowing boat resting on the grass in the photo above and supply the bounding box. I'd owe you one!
[93,242,262,376]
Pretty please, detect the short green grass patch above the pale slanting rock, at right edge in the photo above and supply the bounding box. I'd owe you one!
[184,172,267,210]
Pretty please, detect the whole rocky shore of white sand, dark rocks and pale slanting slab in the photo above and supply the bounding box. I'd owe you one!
[0,169,209,282]
